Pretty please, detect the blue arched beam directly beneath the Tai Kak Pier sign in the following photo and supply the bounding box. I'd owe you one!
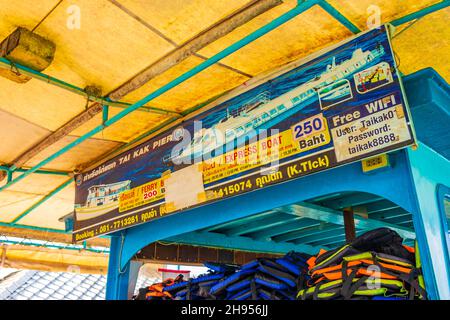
[109,152,414,298]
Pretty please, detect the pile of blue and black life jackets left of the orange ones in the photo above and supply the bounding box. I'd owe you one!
[163,252,310,300]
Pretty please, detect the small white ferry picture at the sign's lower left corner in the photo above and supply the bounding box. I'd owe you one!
[75,180,131,221]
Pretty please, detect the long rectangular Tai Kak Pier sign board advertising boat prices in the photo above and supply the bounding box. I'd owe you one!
[74,26,414,241]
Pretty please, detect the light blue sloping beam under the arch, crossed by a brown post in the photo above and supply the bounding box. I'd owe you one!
[276,202,416,239]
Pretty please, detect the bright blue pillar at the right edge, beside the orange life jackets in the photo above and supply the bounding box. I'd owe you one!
[407,142,450,300]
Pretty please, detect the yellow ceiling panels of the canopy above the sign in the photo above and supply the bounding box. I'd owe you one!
[0,0,450,229]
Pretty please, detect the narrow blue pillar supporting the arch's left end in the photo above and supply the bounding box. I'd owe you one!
[106,232,130,300]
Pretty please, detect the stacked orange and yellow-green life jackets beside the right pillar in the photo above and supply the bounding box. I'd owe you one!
[297,228,426,300]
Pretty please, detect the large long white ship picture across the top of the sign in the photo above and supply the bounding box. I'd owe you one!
[164,44,385,164]
